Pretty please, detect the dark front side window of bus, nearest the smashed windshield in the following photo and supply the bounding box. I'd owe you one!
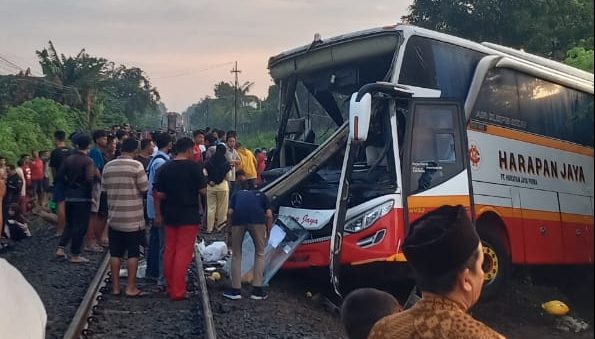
[399,36,484,100]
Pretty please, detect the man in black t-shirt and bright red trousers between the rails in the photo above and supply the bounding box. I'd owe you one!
[153,138,207,300]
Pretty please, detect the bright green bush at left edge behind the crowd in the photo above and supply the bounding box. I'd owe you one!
[0,98,80,163]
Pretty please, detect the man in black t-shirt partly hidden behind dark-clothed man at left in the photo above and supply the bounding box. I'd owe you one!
[49,131,72,235]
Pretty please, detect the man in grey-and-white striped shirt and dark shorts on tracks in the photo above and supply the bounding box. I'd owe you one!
[101,138,148,297]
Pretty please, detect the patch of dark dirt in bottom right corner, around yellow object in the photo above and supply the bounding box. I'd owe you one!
[471,266,594,339]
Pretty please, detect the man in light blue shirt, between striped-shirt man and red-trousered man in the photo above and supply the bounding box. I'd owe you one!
[146,133,172,291]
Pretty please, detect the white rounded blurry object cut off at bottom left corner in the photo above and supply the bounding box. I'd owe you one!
[0,258,47,339]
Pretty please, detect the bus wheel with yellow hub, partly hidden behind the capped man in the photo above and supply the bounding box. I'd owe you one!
[479,227,511,299]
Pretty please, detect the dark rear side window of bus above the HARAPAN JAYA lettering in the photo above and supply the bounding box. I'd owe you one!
[472,68,593,146]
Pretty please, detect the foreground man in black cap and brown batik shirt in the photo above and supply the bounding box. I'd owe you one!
[368,205,504,339]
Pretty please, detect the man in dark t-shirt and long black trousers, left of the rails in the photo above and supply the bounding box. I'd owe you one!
[56,135,101,263]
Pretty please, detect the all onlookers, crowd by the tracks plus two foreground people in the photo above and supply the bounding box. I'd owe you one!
[0,122,502,339]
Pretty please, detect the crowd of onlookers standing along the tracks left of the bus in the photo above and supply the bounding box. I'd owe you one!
[0,125,272,300]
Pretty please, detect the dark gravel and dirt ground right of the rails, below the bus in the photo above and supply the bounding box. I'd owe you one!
[204,239,594,339]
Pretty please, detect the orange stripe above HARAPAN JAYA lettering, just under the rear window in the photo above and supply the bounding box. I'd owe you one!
[473,125,594,157]
